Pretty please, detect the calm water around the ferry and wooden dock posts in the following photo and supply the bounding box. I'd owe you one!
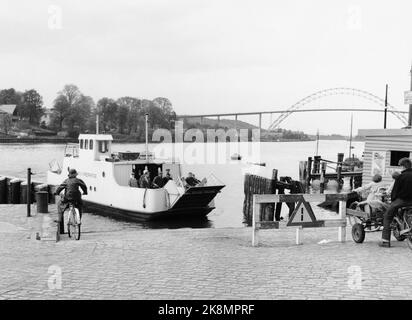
[0,141,364,228]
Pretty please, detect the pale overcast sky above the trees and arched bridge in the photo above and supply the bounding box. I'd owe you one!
[0,0,412,134]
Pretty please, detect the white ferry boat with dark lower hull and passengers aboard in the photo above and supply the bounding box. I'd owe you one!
[47,134,224,221]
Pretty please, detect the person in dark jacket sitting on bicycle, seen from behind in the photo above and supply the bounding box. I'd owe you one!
[54,169,87,231]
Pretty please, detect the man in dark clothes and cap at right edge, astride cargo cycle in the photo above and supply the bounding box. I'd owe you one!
[379,158,412,248]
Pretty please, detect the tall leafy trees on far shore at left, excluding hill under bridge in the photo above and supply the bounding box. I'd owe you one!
[0,84,176,141]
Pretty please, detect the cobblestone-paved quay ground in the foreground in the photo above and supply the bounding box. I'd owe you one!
[0,205,412,299]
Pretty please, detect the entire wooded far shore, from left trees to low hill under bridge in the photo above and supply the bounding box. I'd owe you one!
[0,84,318,142]
